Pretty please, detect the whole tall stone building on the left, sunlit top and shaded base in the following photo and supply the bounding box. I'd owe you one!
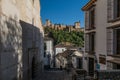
[0,0,44,80]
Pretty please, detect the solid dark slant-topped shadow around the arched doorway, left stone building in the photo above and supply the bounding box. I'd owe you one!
[20,20,43,80]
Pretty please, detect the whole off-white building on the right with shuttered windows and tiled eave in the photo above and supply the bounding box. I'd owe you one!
[82,0,120,76]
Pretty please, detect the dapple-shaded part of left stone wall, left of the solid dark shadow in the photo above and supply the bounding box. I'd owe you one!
[0,15,22,80]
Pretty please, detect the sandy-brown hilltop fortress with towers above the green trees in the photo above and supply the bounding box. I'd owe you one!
[44,19,84,32]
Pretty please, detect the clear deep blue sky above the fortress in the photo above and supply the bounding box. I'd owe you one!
[40,0,89,27]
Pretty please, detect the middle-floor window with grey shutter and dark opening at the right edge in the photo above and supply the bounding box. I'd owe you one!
[107,28,120,55]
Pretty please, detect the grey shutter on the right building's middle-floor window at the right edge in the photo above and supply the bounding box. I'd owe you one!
[107,29,113,55]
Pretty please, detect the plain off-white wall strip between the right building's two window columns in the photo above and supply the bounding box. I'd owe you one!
[95,0,108,69]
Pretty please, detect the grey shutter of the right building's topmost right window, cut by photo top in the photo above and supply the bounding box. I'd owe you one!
[107,0,114,21]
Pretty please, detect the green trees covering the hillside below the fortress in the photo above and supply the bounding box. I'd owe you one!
[44,27,84,47]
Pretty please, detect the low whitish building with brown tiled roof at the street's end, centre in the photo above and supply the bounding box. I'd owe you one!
[56,50,83,69]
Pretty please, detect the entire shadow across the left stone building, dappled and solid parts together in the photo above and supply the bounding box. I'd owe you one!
[0,15,43,80]
